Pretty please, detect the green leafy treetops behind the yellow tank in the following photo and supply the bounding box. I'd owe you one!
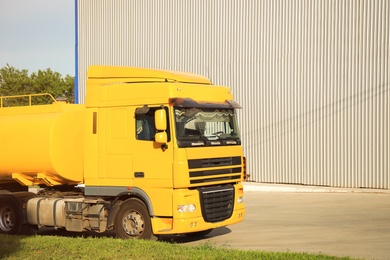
[0,64,74,106]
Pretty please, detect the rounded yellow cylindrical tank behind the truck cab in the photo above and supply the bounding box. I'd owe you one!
[0,102,85,186]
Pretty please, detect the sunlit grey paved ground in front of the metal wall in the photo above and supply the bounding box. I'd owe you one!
[161,186,390,259]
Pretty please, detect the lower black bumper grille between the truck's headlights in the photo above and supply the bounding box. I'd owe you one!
[198,185,234,223]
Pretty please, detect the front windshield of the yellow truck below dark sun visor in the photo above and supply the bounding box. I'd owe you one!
[175,108,241,147]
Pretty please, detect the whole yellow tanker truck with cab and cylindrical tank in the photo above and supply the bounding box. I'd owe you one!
[0,66,246,239]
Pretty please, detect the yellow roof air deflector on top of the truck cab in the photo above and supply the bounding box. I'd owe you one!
[87,65,211,85]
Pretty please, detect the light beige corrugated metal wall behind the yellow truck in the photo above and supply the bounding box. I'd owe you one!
[77,0,390,189]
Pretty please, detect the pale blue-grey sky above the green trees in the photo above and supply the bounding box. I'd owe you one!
[0,0,75,76]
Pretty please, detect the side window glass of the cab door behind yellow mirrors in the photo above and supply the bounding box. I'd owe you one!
[135,107,170,141]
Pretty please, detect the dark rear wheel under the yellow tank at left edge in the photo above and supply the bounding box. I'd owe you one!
[0,199,24,234]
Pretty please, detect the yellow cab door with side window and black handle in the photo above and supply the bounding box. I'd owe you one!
[133,106,173,216]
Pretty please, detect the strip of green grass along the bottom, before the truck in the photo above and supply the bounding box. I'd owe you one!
[0,235,350,260]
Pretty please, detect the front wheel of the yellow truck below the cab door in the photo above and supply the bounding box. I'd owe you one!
[115,198,153,239]
